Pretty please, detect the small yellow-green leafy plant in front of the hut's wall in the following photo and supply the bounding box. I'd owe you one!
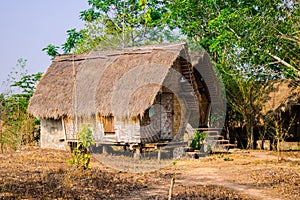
[69,125,94,170]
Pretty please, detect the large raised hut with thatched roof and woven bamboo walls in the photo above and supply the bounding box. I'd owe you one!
[28,43,209,148]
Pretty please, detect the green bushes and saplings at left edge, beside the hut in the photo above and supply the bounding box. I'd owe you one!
[0,59,42,150]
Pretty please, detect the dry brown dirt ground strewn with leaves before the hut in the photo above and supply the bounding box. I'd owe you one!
[0,148,300,200]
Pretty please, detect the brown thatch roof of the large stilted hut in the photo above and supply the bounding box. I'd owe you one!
[28,43,192,119]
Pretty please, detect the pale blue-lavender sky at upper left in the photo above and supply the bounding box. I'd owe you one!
[0,0,89,92]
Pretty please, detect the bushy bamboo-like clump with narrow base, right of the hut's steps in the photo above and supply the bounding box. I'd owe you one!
[225,76,273,148]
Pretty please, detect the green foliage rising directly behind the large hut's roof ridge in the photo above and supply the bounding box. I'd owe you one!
[44,0,180,57]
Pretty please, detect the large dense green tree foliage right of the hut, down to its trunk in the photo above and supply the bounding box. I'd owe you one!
[165,0,300,148]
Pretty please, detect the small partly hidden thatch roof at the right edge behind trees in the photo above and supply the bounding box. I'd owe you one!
[262,79,300,114]
